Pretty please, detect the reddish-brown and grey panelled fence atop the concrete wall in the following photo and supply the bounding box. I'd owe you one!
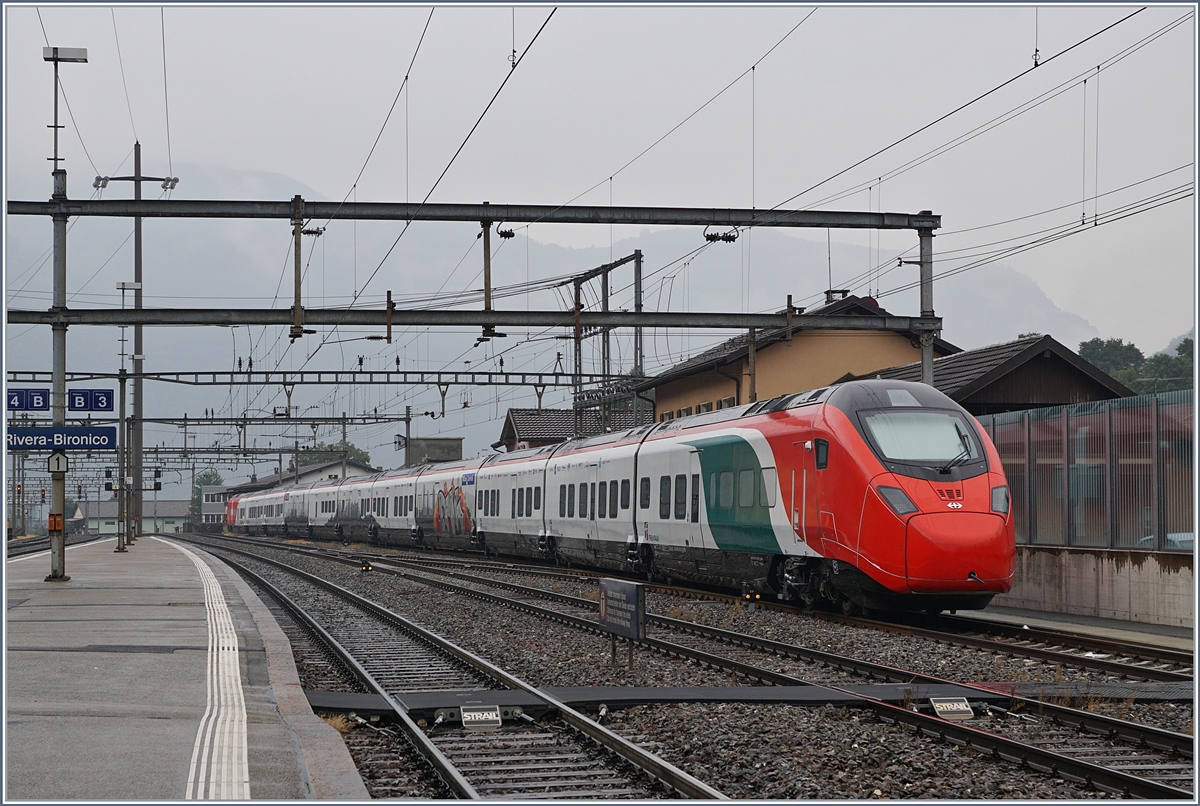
[978,389,1195,552]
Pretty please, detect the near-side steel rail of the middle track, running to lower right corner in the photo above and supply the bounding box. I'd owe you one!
[357,559,1194,800]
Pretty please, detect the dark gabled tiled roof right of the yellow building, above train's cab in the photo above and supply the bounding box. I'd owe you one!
[846,336,1133,401]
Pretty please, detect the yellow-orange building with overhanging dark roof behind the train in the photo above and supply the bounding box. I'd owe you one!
[638,296,961,421]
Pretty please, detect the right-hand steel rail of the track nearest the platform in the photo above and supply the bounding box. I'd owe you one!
[192,534,728,800]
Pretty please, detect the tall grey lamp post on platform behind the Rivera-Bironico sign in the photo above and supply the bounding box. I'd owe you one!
[42,48,88,582]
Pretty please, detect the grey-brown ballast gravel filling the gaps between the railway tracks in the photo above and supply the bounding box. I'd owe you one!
[201,549,1192,799]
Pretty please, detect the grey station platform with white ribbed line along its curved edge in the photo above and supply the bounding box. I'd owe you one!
[4,535,370,802]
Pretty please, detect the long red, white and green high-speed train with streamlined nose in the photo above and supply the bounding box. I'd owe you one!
[227,380,1015,612]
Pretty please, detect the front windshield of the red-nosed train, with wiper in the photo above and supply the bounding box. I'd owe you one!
[862,409,983,470]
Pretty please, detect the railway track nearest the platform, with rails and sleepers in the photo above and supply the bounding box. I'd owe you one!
[199,547,724,799]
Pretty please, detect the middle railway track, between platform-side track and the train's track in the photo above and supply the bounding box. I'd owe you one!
[192,534,1193,798]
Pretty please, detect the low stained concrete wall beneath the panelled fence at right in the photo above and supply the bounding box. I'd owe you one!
[992,546,1195,627]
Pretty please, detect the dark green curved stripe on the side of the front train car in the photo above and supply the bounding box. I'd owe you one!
[686,434,784,554]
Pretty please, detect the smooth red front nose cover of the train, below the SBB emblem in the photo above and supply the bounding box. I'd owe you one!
[905,512,1016,594]
